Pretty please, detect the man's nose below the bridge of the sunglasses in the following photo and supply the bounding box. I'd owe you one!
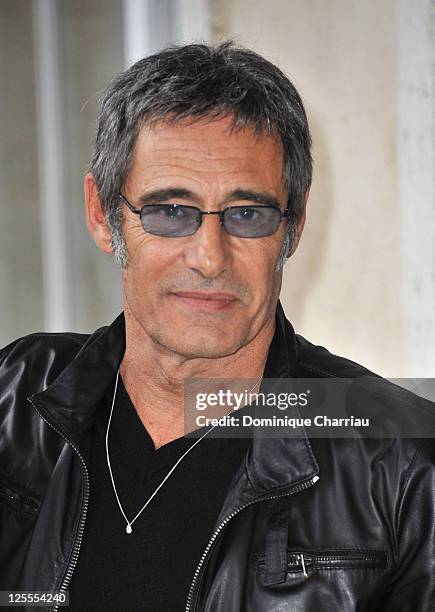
[184,215,231,278]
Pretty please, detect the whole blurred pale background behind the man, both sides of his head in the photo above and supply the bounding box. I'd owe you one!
[0,0,435,377]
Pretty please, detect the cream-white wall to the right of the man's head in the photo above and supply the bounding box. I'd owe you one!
[213,0,435,377]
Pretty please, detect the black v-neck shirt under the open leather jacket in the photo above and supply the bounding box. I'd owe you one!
[69,376,252,612]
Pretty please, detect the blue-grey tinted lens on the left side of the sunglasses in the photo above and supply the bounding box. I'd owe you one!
[141,204,201,238]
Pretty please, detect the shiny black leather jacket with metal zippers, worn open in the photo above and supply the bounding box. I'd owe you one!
[0,305,435,612]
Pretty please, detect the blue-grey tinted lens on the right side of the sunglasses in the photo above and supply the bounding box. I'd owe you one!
[224,206,281,238]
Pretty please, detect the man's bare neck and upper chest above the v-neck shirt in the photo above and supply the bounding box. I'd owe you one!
[120,314,275,448]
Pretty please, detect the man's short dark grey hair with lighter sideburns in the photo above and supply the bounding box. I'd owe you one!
[90,41,312,269]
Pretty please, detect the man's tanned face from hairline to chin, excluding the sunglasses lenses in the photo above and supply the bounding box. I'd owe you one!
[123,118,287,358]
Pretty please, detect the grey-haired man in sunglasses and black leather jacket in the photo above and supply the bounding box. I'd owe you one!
[0,43,435,612]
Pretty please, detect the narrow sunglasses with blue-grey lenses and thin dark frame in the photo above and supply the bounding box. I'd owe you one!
[119,193,289,238]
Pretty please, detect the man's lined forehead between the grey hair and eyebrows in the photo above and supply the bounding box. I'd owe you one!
[127,117,284,195]
